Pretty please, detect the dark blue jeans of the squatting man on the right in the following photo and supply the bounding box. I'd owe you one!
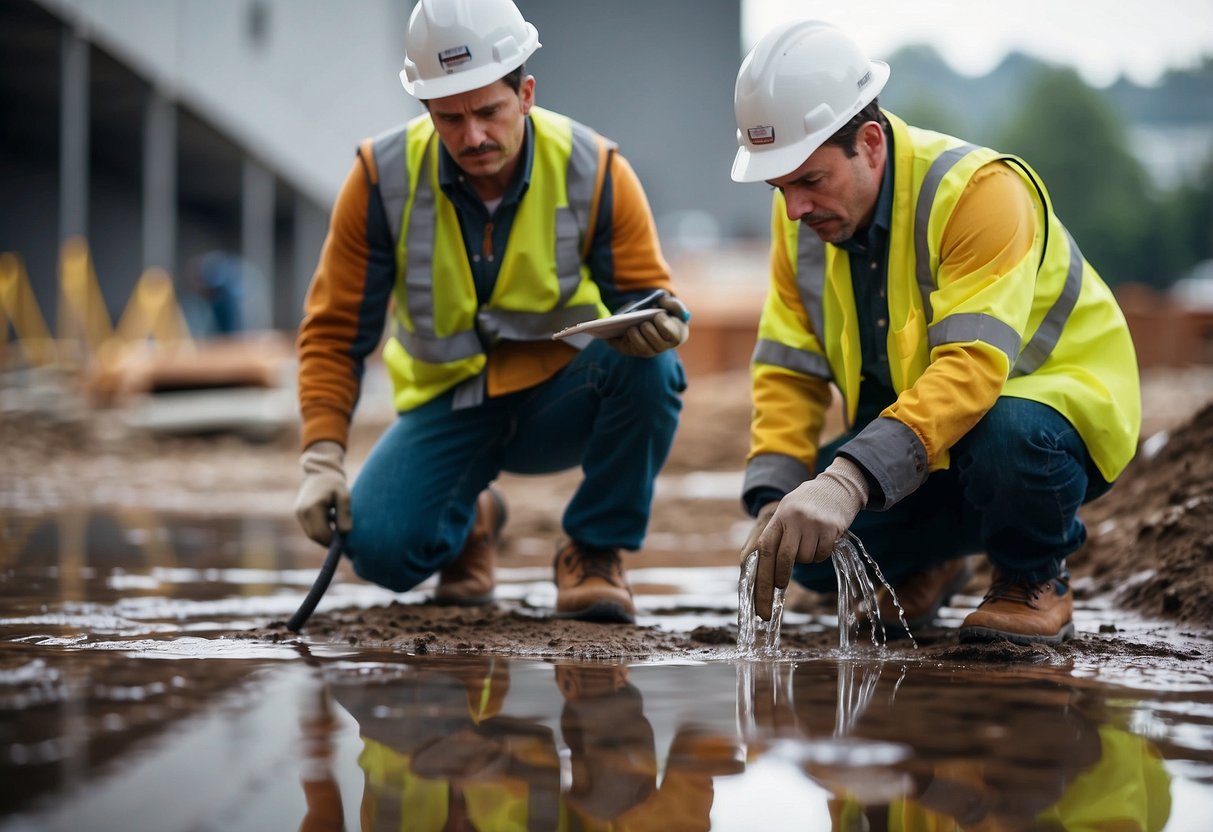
[792,397,1111,592]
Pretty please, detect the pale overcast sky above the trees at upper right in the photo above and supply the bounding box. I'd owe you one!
[742,0,1213,86]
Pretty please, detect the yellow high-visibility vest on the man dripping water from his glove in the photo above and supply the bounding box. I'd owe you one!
[747,113,1141,497]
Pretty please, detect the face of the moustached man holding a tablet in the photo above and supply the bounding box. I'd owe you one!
[429,75,535,185]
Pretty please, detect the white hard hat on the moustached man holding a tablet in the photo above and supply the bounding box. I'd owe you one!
[400,0,540,99]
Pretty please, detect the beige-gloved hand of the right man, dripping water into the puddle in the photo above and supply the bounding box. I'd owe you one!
[754,456,867,621]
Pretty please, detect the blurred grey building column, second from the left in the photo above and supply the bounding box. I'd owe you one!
[143,90,177,274]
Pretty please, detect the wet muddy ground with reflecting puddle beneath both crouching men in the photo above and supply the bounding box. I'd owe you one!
[7,367,1213,832]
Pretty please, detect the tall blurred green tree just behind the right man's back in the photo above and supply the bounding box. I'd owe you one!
[995,67,1154,287]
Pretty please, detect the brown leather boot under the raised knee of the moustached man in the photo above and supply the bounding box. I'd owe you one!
[556,540,636,623]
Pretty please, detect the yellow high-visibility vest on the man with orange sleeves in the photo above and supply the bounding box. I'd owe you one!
[374,107,613,412]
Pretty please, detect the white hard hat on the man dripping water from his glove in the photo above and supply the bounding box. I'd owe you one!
[733,21,889,182]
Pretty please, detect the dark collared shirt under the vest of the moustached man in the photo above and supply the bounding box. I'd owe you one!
[438,119,535,306]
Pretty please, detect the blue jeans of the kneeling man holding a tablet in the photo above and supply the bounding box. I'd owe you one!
[346,341,687,592]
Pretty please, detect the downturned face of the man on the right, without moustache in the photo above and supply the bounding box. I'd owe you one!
[768,121,885,244]
